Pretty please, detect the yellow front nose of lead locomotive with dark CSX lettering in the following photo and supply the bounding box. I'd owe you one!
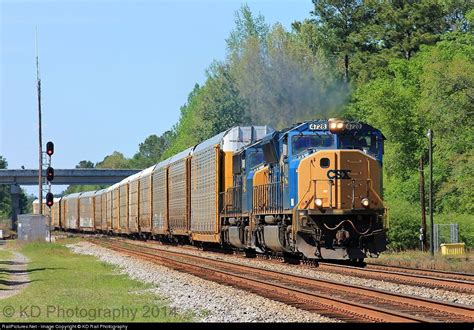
[298,150,383,211]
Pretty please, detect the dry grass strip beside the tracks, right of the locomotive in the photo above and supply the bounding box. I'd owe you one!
[366,250,474,273]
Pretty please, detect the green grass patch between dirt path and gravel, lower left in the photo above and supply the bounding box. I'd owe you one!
[0,239,192,322]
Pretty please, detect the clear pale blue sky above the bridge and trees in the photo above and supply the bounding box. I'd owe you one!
[0,0,312,195]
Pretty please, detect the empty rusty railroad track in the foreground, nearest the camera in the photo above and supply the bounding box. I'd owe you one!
[90,239,474,322]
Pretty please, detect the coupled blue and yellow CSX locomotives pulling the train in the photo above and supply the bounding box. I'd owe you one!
[220,119,386,261]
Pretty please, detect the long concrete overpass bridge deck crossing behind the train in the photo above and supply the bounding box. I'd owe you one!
[0,168,141,186]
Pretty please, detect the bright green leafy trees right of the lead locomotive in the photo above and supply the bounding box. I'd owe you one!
[346,31,474,246]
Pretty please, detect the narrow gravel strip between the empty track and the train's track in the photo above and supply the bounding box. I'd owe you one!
[137,241,474,306]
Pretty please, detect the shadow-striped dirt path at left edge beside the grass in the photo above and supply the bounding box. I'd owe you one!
[0,251,30,299]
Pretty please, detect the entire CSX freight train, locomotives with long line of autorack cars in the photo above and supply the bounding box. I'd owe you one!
[35,119,386,261]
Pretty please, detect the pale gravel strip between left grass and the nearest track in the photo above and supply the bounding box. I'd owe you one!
[67,242,337,322]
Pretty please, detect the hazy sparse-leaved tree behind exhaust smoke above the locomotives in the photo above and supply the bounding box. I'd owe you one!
[228,9,347,128]
